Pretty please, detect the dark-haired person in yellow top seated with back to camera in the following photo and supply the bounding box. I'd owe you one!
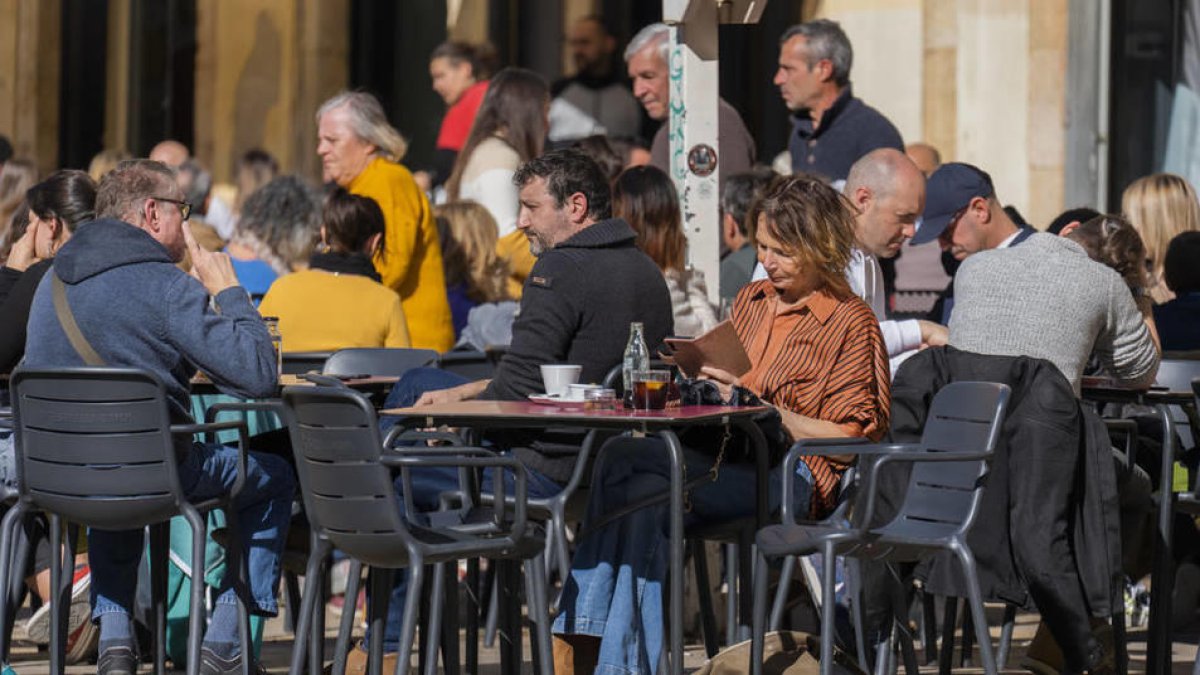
[258,187,412,352]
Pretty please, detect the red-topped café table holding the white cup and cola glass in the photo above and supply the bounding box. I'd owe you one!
[379,401,770,673]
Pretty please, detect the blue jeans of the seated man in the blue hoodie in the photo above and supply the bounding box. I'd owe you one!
[88,443,295,619]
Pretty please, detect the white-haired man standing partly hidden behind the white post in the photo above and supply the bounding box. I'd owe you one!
[625,23,755,191]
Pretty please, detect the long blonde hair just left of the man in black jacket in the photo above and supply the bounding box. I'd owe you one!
[433,201,509,303]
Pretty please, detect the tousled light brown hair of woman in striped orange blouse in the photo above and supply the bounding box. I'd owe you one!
[746,175,854,298]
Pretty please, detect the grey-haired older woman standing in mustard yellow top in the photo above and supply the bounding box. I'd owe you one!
[317,91,454,352]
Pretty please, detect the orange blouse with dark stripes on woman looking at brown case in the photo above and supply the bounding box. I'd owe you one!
[733,280,892,515]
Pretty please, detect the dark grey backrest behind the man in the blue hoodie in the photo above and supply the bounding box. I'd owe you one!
[12,368,182,530]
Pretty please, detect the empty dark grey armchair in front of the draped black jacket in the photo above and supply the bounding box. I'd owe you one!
[750,382,1009,675]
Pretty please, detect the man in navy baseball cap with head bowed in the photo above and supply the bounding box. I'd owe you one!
[911,162,1037,325]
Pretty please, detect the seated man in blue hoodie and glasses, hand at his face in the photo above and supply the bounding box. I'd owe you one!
[25,160,295,675]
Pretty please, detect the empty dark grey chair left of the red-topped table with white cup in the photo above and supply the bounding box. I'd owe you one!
[283,387,553,675]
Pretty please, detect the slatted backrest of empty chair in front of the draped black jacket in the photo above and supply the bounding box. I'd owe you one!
[889,382,1009,533]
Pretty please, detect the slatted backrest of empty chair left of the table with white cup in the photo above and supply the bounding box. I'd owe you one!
[283,387,407,567]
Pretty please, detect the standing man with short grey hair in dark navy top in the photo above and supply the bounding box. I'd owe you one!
[774,19,904,181]
